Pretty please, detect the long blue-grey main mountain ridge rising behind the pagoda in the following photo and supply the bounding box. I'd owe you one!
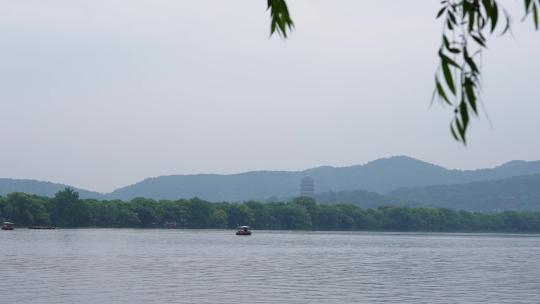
[106,156,540,201]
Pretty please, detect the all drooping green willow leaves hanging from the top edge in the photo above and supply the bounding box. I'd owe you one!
[268,0,540,144]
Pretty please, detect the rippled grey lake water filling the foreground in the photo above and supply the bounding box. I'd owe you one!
[0,229,540,304]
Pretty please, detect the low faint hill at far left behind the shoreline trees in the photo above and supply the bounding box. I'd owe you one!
[0,178,103,199]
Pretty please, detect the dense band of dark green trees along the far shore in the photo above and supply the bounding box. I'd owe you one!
[0,188,540,232]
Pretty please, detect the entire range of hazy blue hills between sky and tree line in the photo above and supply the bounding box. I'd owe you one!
[0,156,540,209]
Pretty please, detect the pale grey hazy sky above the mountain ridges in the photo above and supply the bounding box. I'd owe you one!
[0,0,540,192]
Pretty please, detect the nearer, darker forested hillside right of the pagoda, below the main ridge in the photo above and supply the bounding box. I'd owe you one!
[315,174,540,212]
